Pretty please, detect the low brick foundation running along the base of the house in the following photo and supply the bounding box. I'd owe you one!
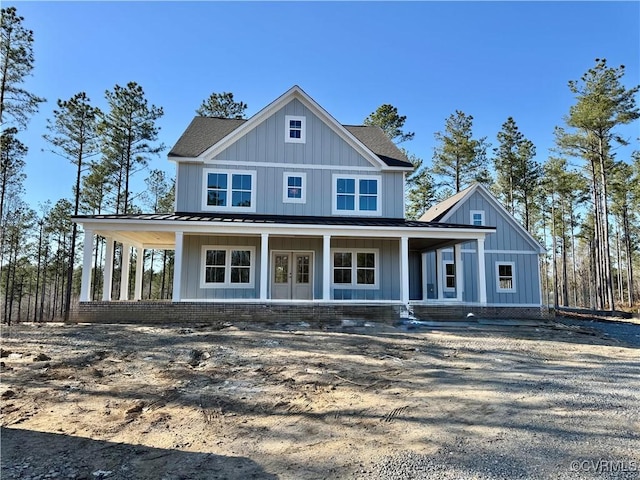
[70,301,548,325]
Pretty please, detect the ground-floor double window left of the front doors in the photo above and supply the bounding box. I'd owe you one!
[201,245,255,288]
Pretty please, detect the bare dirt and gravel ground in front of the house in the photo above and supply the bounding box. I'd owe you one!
[0,321,640,480]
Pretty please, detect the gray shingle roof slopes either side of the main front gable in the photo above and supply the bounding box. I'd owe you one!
[169,117,412,167]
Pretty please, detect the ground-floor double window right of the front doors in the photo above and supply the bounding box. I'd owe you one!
[331,249,379,288]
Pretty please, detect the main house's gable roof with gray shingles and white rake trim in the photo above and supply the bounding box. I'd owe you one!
[168,85,413,170]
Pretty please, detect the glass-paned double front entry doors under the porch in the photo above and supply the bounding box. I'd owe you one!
[271,252,313,300]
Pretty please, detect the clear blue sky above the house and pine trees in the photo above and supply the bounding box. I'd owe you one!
[8,1,640,207]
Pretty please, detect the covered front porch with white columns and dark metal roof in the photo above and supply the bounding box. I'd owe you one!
[76,215,494,306]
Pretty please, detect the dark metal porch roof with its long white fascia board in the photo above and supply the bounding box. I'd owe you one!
[77,219,495,240]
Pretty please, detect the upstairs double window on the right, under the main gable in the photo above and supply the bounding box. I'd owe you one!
[333,174,381,215]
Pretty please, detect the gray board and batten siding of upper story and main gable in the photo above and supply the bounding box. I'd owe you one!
[176,100,404,218]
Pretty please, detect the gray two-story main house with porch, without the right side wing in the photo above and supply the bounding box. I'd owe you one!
[75,86,544,319]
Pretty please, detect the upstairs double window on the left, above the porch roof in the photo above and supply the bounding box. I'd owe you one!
[202,169,256,212]
